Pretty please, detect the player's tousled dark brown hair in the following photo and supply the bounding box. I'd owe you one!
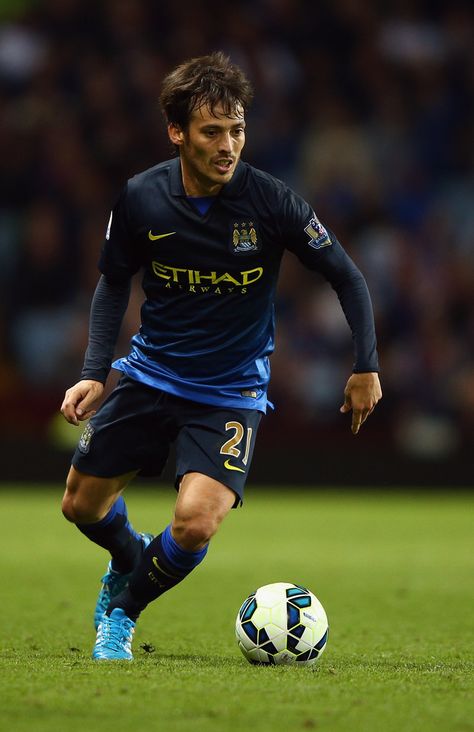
[160,51,253,129]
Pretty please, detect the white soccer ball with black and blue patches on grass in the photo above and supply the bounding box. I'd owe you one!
[235,582,328,665]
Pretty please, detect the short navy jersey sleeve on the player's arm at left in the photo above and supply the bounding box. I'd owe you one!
[99,185,142,282]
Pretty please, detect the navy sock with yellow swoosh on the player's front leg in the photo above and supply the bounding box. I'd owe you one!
[107,526,209,620]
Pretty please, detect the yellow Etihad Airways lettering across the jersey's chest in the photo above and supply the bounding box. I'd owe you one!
[151,261,263,295]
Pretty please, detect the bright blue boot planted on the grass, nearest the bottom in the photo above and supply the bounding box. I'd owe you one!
[92,607,135,661]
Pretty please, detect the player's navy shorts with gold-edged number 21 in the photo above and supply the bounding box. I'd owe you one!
[72,376,262,505]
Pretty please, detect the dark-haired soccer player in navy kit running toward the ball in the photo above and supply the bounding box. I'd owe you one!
[61,53,381,660]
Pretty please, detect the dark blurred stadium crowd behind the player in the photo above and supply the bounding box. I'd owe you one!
[0,0,474,487]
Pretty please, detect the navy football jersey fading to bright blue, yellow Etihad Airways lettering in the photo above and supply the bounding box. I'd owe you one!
[96,158,377,411]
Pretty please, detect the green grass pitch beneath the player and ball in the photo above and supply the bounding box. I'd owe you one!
[0,484,474,732]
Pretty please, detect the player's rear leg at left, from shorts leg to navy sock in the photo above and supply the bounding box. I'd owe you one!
[63,377,170,573]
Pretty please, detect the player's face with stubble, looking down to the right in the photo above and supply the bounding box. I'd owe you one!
[168,101,245,196]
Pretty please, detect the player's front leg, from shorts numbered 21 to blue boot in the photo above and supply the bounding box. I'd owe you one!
[92,399,261,660]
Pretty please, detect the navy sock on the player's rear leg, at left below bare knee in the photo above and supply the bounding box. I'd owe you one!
[76,496,143,574]
